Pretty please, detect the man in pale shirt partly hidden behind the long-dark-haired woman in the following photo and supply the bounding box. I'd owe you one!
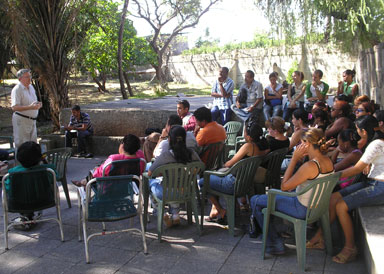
[143,114,197,162]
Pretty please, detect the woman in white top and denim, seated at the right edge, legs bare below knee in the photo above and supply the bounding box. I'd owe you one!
[307,115,384,263]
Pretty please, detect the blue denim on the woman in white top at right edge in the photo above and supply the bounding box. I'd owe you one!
[339,180,384,210]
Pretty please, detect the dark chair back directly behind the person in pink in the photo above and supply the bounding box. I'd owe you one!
[103,158,146,177]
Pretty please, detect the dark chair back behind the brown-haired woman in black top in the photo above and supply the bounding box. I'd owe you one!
[262,148,288,189]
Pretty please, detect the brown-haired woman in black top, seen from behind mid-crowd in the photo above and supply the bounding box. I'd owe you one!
[265,116,289,151]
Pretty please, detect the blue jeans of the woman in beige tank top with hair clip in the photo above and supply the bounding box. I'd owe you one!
[251,194,307,246]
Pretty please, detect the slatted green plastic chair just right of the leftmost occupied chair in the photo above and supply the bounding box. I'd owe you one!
[45,147,72,208]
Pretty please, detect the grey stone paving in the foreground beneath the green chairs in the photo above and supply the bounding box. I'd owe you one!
[0,158,366,274]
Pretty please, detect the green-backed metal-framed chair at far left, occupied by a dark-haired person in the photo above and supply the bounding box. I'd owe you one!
[2,168,64,250]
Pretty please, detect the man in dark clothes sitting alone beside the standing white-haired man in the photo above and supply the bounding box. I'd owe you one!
[64,105,93,158]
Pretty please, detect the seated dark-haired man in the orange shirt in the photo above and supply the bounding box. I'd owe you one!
[194,107,227,163]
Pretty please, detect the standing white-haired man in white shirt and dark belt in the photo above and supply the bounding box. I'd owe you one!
[11,69,42,150]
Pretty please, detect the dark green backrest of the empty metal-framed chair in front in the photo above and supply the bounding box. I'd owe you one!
[85,175,140,221]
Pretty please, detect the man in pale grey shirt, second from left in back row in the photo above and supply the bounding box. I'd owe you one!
[231,70,263,125]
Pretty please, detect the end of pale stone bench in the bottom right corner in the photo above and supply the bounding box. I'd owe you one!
[357,206,384,274]
